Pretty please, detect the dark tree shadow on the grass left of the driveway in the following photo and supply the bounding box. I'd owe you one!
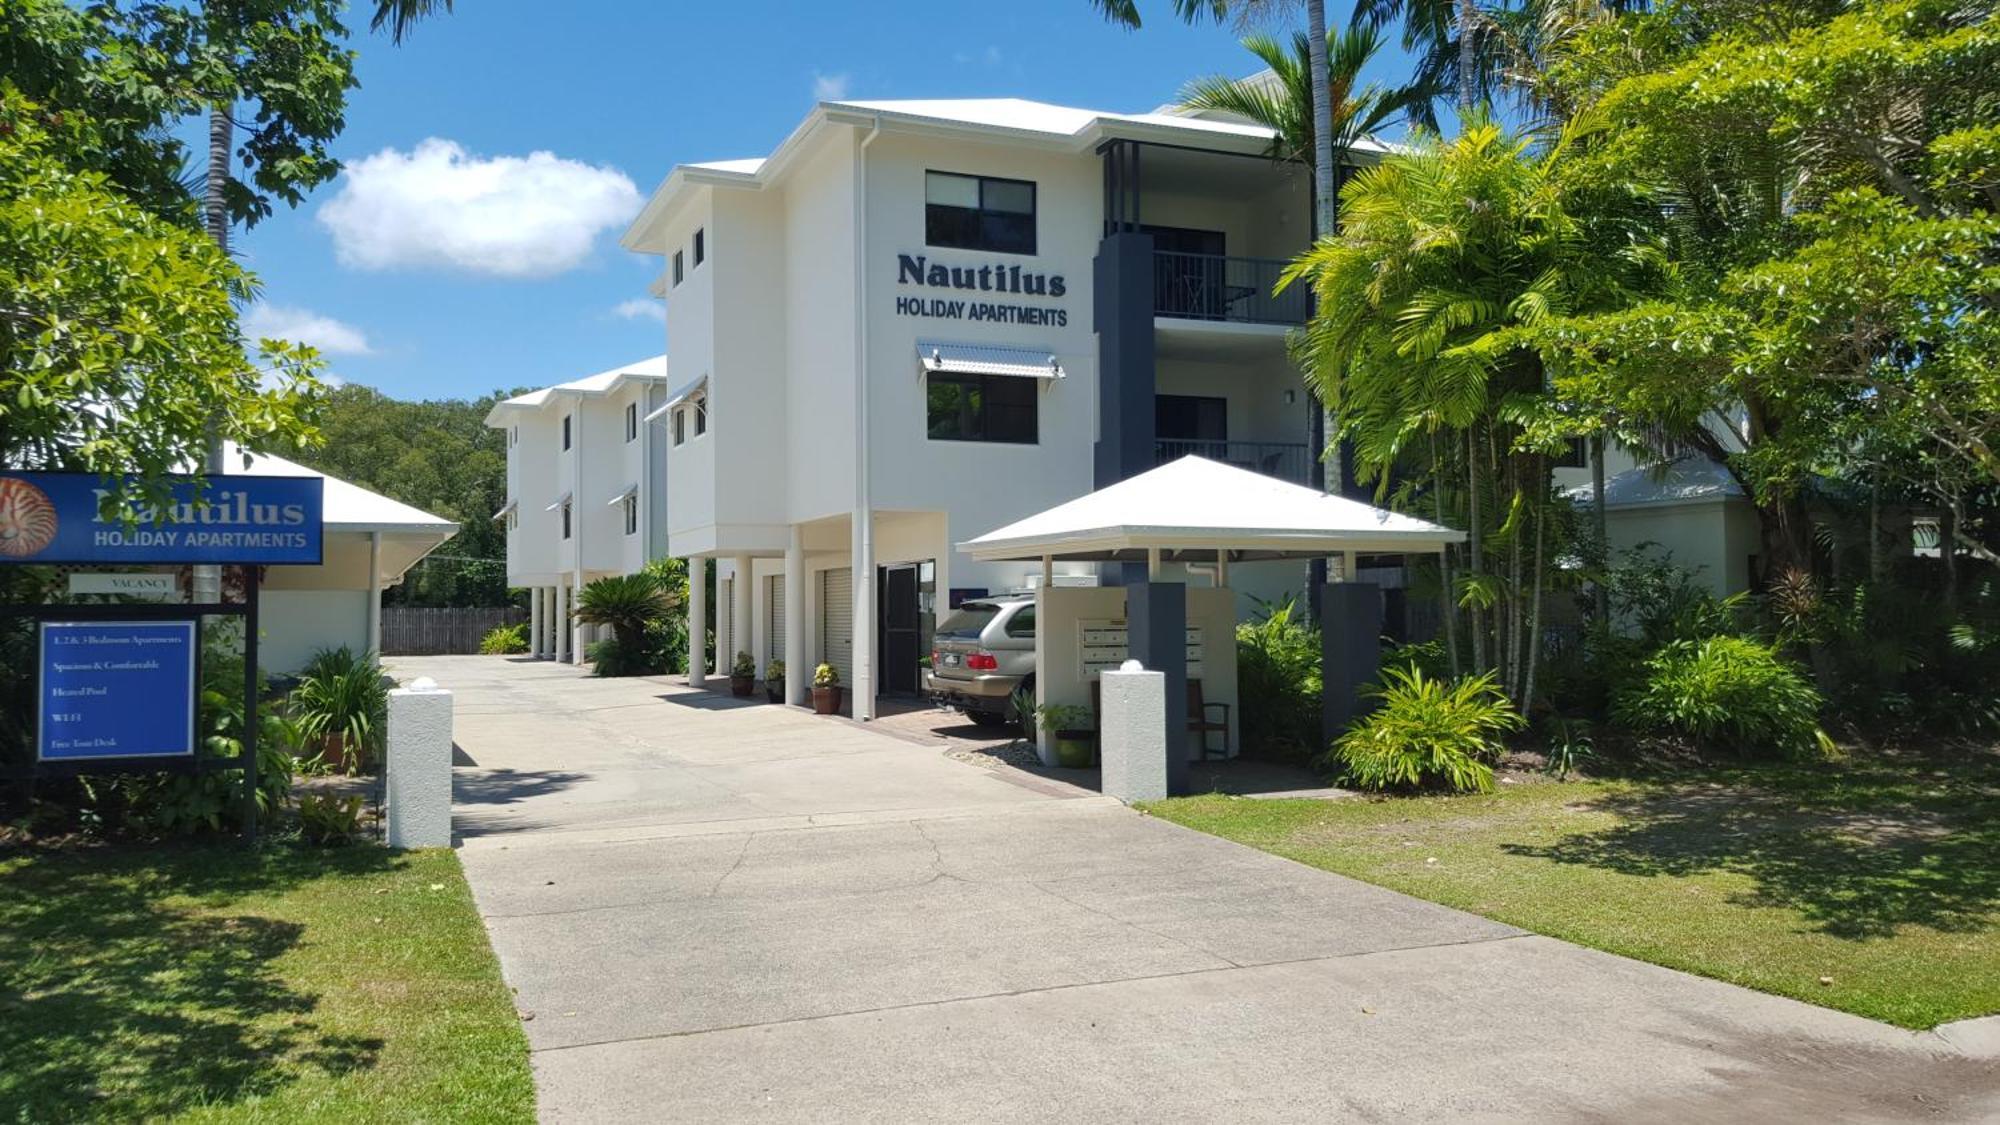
[0,845,398,1121]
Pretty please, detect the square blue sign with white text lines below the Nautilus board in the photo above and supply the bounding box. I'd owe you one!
[34,621,196,763]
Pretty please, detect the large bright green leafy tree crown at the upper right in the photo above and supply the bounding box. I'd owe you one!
[1538,0,2000,573]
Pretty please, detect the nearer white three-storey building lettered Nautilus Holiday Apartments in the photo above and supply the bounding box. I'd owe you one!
[624,98,1752,719]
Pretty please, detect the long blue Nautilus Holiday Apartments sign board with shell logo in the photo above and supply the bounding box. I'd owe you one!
[0,472,326,567]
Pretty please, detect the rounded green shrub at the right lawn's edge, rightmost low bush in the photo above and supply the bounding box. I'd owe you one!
[1612,637,1832,757]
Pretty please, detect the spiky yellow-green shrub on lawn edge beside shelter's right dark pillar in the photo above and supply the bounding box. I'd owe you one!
[1328,669,1522,793]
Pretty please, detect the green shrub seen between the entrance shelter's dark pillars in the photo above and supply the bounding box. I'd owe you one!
[1236,599,1320,765]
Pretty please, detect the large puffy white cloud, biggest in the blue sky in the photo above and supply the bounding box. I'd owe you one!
[318,136,642,278]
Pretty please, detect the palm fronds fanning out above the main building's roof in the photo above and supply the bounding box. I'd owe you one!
[1180,28,1412,208]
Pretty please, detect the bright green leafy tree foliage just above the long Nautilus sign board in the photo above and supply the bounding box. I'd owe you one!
[0,84,318,504]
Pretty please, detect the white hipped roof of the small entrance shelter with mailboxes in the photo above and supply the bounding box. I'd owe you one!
[958,456,1464,563]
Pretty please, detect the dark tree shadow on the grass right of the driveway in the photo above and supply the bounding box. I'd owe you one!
[1502,751,2000,941]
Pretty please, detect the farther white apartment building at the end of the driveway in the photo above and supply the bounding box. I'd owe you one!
[486,356,668,663]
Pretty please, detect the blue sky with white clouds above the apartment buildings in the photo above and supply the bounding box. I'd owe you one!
[238,0,1404,398]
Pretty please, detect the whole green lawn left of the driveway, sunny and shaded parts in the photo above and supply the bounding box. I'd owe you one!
[0,845,534,1123]
